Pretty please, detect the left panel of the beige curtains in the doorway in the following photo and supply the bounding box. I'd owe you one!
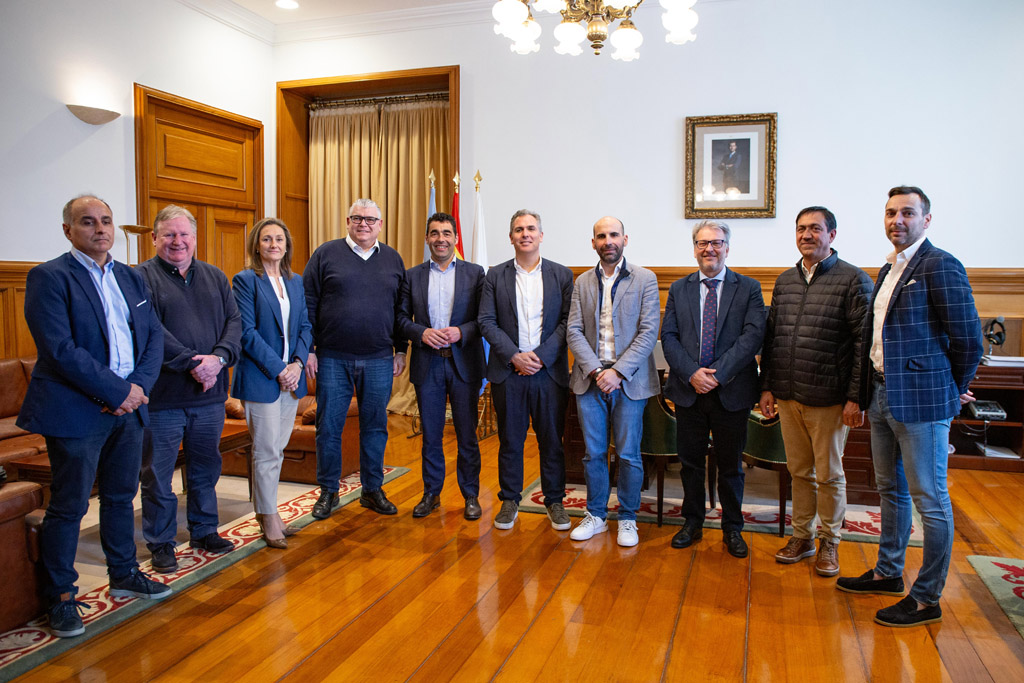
[309,104,383,245]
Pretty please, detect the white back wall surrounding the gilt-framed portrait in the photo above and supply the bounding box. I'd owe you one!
[274,0,1024,267]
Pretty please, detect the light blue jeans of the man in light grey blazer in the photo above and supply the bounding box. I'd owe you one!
[577,382,647,520]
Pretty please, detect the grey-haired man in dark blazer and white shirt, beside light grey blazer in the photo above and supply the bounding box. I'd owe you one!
[479,209,572,530]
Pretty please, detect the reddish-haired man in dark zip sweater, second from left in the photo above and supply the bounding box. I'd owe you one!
[138,204,242,572]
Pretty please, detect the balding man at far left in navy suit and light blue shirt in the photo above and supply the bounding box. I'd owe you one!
[17,196,171,638]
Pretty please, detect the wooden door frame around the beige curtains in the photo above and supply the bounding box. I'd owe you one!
[276,65,460,270]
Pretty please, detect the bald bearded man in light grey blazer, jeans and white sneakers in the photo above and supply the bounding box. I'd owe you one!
[565,216,660,547]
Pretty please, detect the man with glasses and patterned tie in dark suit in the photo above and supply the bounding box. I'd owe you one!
[662,220,765,557]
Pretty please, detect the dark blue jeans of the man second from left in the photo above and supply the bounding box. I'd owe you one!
[142,402,224,550]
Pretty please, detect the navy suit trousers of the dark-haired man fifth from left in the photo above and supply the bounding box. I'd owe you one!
[416,351,480,498]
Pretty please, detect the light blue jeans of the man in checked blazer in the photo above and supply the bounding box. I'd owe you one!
[867,382,953,605]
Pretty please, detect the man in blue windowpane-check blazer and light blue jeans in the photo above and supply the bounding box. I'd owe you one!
[836,186,982,627]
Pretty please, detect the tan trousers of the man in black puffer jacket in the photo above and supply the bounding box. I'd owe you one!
[778,400,849,541]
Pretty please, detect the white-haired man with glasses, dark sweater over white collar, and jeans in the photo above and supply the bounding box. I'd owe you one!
[302,199,406,519]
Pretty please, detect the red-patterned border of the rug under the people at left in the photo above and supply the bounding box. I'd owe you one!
[0,466,409,681]
